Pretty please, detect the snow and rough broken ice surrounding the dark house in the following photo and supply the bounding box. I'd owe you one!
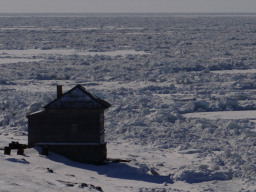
[0,14,256,192]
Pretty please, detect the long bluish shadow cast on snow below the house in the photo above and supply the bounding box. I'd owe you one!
[45,152,173,184]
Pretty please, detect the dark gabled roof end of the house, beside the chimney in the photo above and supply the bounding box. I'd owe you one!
[44,85,111,110]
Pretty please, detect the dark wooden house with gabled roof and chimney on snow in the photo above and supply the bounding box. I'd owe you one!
[27,85,111,163]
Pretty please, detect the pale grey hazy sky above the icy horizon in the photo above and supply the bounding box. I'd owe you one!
[0,0,256,13]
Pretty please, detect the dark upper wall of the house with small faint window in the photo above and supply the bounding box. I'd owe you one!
[28,109,104,146]
